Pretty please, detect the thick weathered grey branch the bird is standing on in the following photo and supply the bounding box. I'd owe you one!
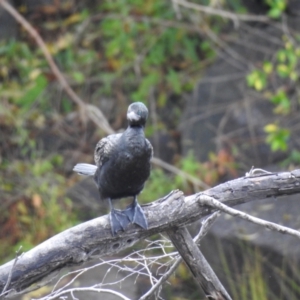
[0,170,300,292]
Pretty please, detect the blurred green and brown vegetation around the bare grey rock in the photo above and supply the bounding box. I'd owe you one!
[0,0,300,299]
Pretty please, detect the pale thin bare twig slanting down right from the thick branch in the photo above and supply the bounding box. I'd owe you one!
[198,194,300,239]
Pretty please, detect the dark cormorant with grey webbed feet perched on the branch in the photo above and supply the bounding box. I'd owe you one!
[74,102,153,235]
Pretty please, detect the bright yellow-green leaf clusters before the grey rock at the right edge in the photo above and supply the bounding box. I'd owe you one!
[246,36,300,151]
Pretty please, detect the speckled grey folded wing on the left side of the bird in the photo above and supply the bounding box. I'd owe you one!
[94,133,122,167]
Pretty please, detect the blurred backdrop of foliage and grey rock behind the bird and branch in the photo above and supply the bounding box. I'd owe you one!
[0,0,300,300]
